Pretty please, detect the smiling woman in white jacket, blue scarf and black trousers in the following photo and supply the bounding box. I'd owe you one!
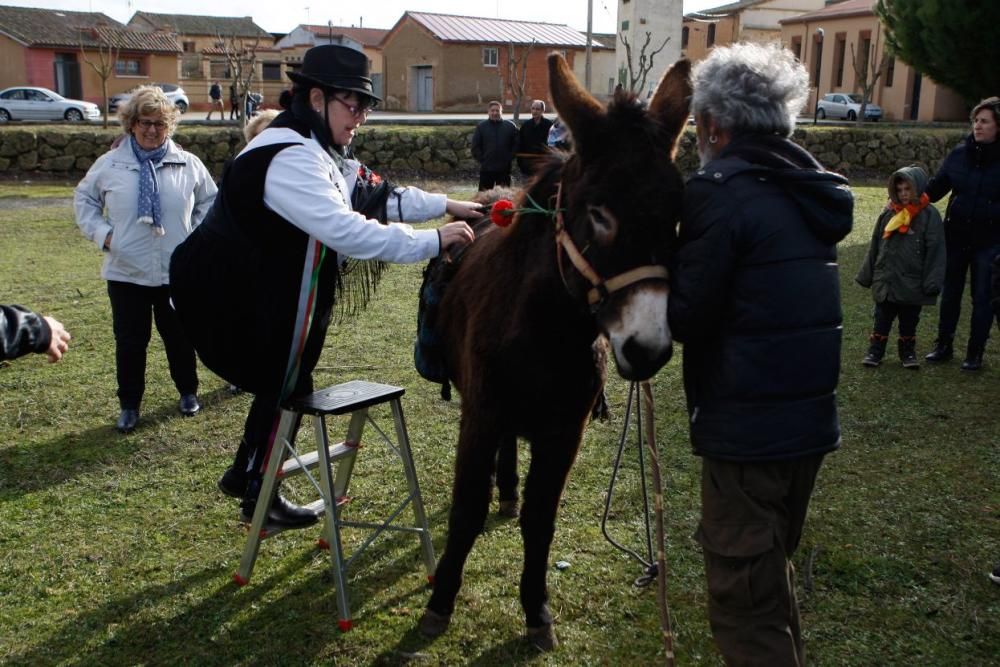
[74,86,217,433]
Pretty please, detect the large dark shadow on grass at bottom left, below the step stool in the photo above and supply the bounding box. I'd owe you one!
[5,554,374,666]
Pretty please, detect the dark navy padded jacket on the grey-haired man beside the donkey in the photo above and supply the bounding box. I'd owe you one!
[669,136,854,461]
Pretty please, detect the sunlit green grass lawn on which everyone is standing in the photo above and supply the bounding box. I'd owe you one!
[0,184,1000,666]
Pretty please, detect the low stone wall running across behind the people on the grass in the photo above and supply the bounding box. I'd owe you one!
[0,125,966,180]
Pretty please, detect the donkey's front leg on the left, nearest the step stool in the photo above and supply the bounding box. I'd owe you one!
[420,416,499,637]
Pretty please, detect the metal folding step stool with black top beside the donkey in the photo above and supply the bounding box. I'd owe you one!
[233,380,435,632]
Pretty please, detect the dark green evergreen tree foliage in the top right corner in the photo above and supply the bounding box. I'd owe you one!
[875,0,1000,104]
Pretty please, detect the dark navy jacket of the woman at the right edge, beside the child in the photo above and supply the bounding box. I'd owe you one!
[926,134,1000,248]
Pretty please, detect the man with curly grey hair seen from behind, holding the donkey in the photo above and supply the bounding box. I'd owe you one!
[669,44,853,665]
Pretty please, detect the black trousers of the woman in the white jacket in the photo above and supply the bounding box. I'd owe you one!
[108,280,198,410]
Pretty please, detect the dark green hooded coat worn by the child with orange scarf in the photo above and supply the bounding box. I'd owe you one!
[854,167,945,306]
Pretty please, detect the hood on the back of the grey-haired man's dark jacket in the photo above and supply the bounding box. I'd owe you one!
[719,135,854,245]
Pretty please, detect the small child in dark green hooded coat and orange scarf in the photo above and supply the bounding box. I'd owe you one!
[854,166,945,370]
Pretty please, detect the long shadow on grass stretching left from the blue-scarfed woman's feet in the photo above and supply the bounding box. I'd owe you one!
[0,387,230,501]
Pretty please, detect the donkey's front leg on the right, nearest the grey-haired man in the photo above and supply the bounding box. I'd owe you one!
[521,428,582,651]
